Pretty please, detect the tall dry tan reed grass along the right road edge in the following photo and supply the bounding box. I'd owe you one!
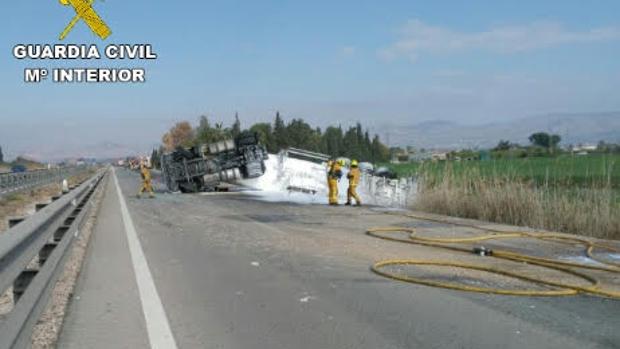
[413,164,620,239]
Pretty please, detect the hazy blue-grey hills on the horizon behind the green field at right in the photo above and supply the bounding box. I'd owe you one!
[382,112,620,149]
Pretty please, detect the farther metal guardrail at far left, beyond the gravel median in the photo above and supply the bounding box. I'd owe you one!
[0,166,88,197]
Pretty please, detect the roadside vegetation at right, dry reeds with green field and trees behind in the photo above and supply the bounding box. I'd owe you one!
[389,137,620,239]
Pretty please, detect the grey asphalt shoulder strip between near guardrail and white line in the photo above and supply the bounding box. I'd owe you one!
[58,169,149,348]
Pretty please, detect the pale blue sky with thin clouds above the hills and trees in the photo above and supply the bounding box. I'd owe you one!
[0,0,620,156]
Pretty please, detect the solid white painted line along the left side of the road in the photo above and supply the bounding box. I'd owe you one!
[112,169,177,349]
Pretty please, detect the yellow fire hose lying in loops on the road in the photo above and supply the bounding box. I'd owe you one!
[366,214,620,298]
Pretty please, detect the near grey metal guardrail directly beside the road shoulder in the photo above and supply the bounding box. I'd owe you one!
[0,170,105,349]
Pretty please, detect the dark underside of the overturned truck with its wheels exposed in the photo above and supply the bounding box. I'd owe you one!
[161,131,268,193]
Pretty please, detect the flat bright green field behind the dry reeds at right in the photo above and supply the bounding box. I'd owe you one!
[387,155,620,190]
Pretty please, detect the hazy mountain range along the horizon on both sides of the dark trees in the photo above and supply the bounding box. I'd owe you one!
[5,111,620,161]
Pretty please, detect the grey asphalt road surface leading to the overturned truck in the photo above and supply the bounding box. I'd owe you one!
[59,170,620,349]
